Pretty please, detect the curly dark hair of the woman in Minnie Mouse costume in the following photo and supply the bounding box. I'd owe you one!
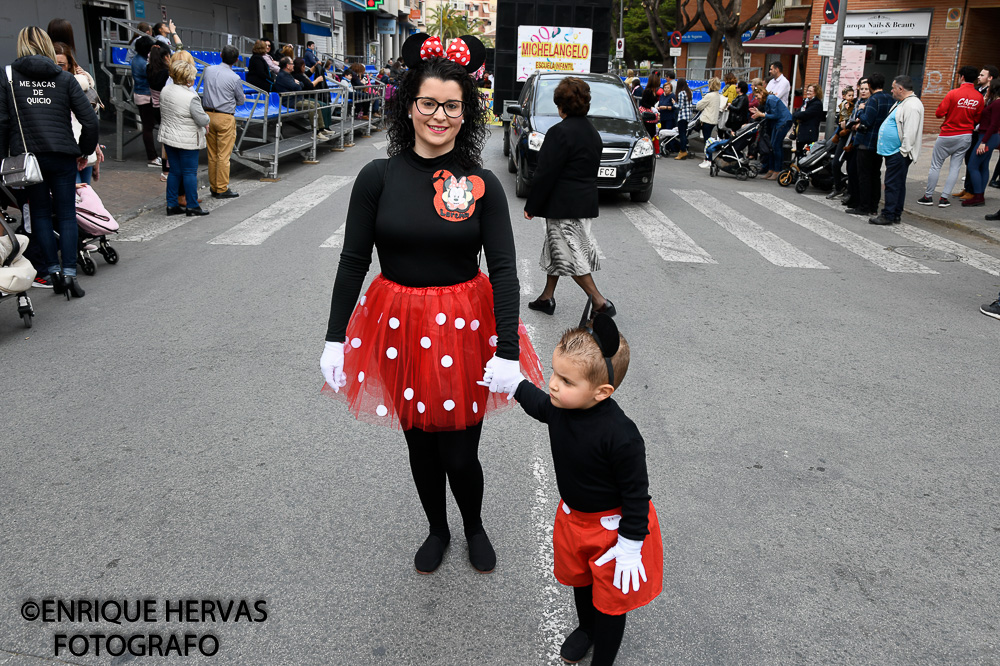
[385,58,489,169]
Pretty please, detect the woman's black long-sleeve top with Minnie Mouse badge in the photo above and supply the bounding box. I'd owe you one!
[326,150,520,361]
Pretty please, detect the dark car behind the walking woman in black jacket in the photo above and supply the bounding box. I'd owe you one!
[504,72,656,201]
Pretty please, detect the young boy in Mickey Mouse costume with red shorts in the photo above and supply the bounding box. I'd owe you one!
[480,314,663,666]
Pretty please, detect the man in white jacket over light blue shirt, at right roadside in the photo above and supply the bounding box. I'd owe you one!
[868,74,924,225]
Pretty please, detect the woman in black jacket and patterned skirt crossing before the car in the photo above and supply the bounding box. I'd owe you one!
[524,76,615,317]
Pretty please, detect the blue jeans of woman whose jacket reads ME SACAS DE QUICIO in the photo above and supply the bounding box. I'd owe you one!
[26,153,77,277]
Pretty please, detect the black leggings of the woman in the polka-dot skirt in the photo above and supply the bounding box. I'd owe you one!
[403,422,483,541]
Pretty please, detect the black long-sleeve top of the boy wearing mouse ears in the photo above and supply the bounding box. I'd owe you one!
[514,380,649,541]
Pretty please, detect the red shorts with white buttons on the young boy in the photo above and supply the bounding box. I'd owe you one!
[552,500,663,615]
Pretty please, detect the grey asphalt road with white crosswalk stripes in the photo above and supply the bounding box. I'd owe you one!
[0,134,1000,666]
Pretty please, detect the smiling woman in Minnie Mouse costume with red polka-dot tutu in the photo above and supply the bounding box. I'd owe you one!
[320,34,542,573]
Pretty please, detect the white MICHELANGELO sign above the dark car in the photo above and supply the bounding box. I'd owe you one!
[517,25,594,81]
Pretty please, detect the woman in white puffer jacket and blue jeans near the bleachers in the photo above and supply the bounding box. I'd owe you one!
[160,59,209,217]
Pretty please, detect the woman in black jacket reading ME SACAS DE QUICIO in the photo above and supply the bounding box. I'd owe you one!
[0,26,100,299]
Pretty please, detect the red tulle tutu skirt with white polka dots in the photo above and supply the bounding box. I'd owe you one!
[322,272,543,432]
